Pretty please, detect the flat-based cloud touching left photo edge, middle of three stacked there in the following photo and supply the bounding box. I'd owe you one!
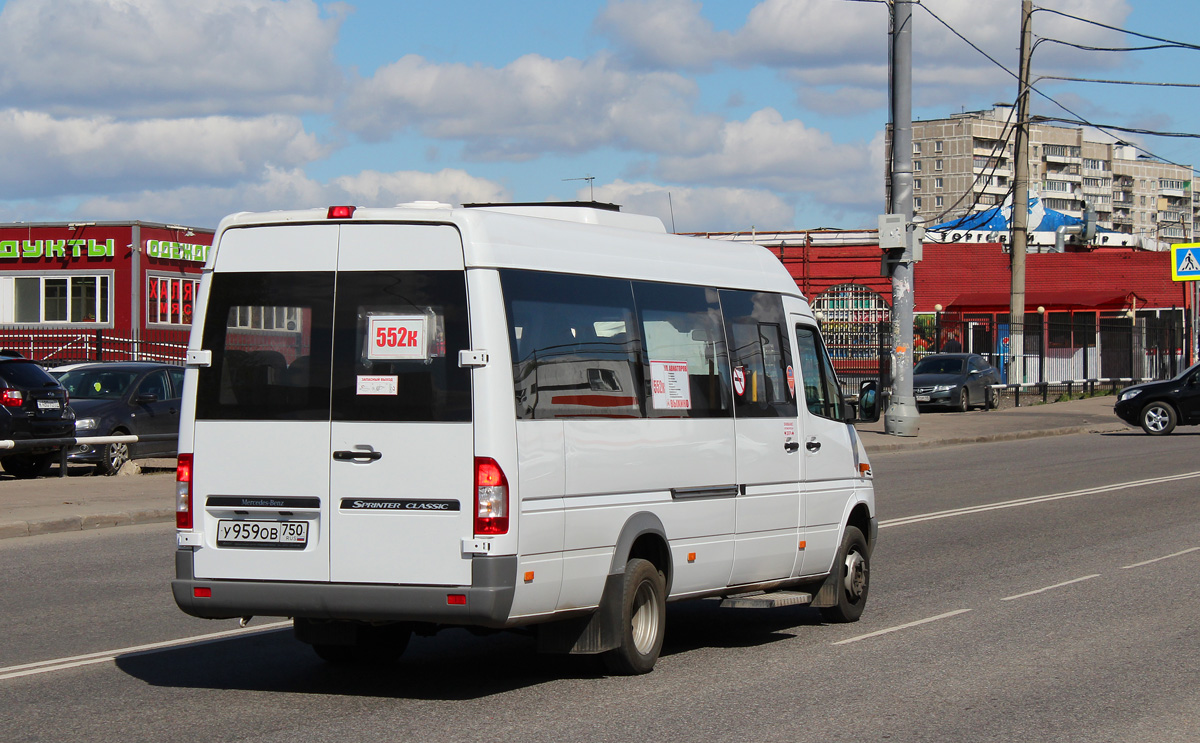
[0,109,325,198]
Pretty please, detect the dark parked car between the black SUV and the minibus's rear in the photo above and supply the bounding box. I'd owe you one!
[59,361,184,474]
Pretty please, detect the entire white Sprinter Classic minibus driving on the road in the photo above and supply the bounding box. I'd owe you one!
[173,202,878,673]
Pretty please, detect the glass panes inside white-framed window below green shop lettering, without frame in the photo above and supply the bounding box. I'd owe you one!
[12,276,112,324]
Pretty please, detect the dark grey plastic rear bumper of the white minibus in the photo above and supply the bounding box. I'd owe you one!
[170,547,517,628]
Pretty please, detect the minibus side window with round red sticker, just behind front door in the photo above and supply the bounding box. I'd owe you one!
[720,289,796,418]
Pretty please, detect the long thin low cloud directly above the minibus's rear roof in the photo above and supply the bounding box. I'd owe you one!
[76,168,510,227]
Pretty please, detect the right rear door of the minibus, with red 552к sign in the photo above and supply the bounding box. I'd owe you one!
[325,224,474,585]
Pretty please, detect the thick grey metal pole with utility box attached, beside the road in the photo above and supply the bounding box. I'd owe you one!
[880,0,920,436]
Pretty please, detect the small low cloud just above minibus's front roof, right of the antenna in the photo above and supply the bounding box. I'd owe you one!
[590,180,796,232]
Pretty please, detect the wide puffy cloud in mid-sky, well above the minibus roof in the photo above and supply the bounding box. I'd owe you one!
[341,54,719,160]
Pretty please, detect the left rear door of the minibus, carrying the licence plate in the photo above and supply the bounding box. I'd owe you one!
[192,224,338,581]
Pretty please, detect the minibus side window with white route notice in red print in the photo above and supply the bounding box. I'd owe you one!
[634,282,733,418]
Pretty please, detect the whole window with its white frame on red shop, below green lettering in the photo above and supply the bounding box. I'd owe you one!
[0,271,114,328]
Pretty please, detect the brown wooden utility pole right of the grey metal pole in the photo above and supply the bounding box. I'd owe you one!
[1008,0,1033,384]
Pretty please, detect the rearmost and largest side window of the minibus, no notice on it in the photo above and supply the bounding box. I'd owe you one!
[500,269,644,420]
